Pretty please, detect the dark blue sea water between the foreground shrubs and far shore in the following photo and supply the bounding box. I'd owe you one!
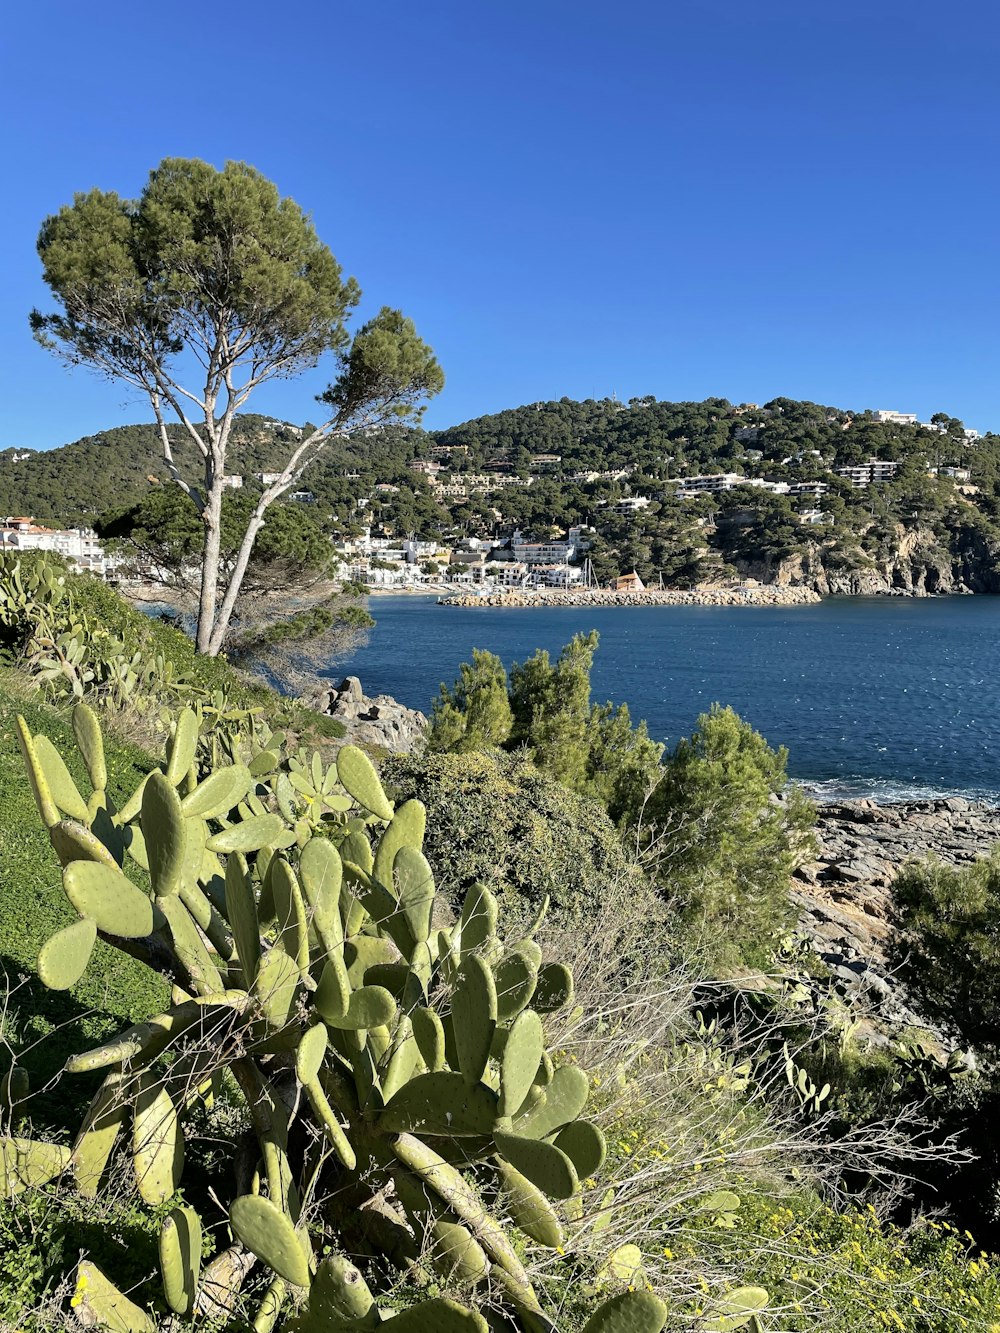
[329,596,1000,802]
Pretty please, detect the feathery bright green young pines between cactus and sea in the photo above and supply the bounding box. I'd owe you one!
[429,631,815,970]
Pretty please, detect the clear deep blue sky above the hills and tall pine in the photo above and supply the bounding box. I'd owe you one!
[0,0,1000,448]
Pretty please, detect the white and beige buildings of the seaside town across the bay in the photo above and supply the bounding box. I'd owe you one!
[0,400,981,605]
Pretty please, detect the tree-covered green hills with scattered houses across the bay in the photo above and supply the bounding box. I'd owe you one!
[7,397,1000,592]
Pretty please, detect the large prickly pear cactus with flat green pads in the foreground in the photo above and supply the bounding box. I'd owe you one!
[11,705,665,1333]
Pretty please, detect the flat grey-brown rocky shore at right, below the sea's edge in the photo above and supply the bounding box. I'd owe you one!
[792,797,1000,1024]
